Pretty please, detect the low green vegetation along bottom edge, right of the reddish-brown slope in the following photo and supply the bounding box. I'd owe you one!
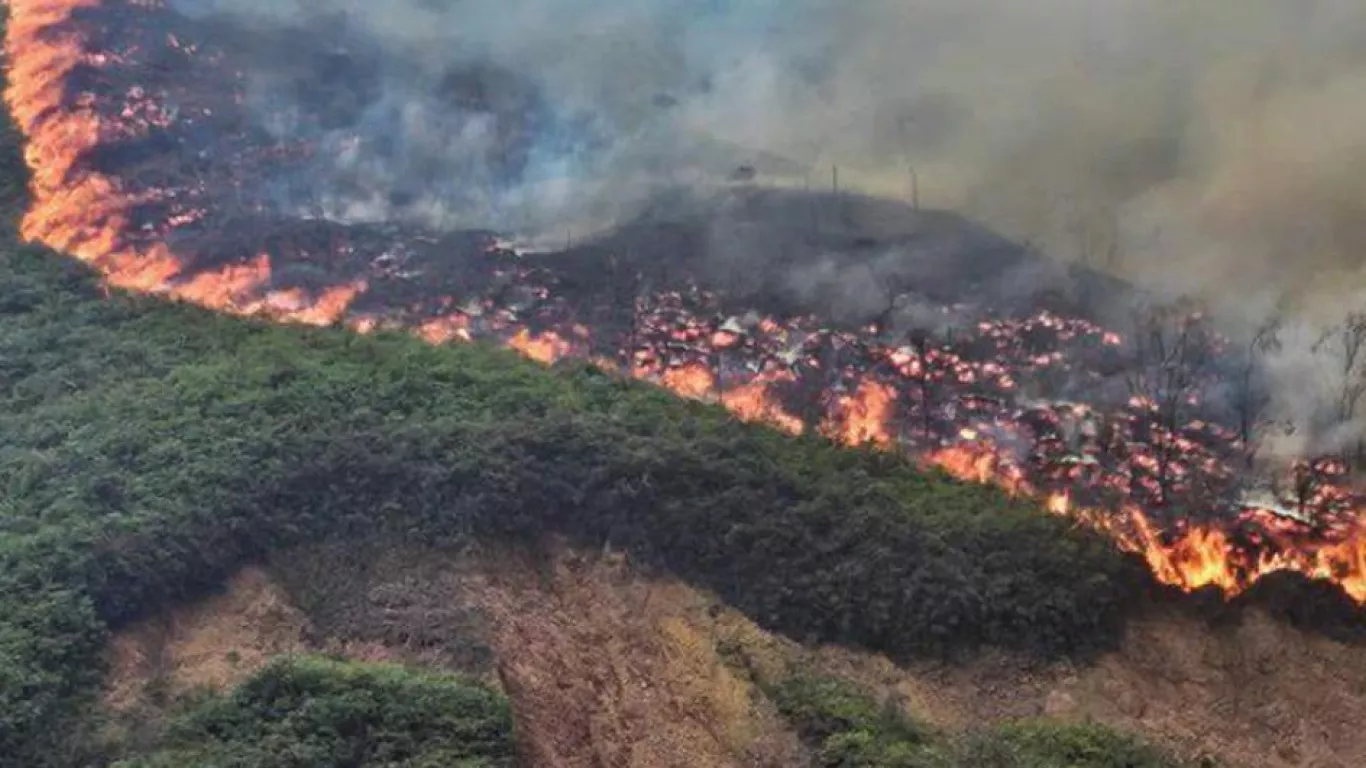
[769,674,1179,768]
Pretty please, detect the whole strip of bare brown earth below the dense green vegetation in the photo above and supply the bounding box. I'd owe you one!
[108,547,1366,768]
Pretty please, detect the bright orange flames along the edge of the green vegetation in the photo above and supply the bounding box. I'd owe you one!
[4,0,1366,603]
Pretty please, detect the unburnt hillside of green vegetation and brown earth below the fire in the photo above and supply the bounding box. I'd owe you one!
[8,94,1361,765]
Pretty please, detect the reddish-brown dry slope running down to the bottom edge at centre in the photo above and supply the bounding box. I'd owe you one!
[453,543,803,768]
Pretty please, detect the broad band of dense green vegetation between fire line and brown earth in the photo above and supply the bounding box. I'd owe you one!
[0,37,1146,768]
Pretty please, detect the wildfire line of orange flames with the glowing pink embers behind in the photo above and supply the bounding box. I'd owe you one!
[4,0,1366,603]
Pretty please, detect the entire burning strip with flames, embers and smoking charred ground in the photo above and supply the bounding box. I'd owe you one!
[13,0,1366,603]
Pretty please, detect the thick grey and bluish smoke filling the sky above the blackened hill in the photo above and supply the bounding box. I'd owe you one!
[173,0,1366,453]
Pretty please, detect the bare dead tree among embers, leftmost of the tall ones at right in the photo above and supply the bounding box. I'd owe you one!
[1126,302,1212,506]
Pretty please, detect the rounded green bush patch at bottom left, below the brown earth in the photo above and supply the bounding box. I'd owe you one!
[115,650,514,768]
